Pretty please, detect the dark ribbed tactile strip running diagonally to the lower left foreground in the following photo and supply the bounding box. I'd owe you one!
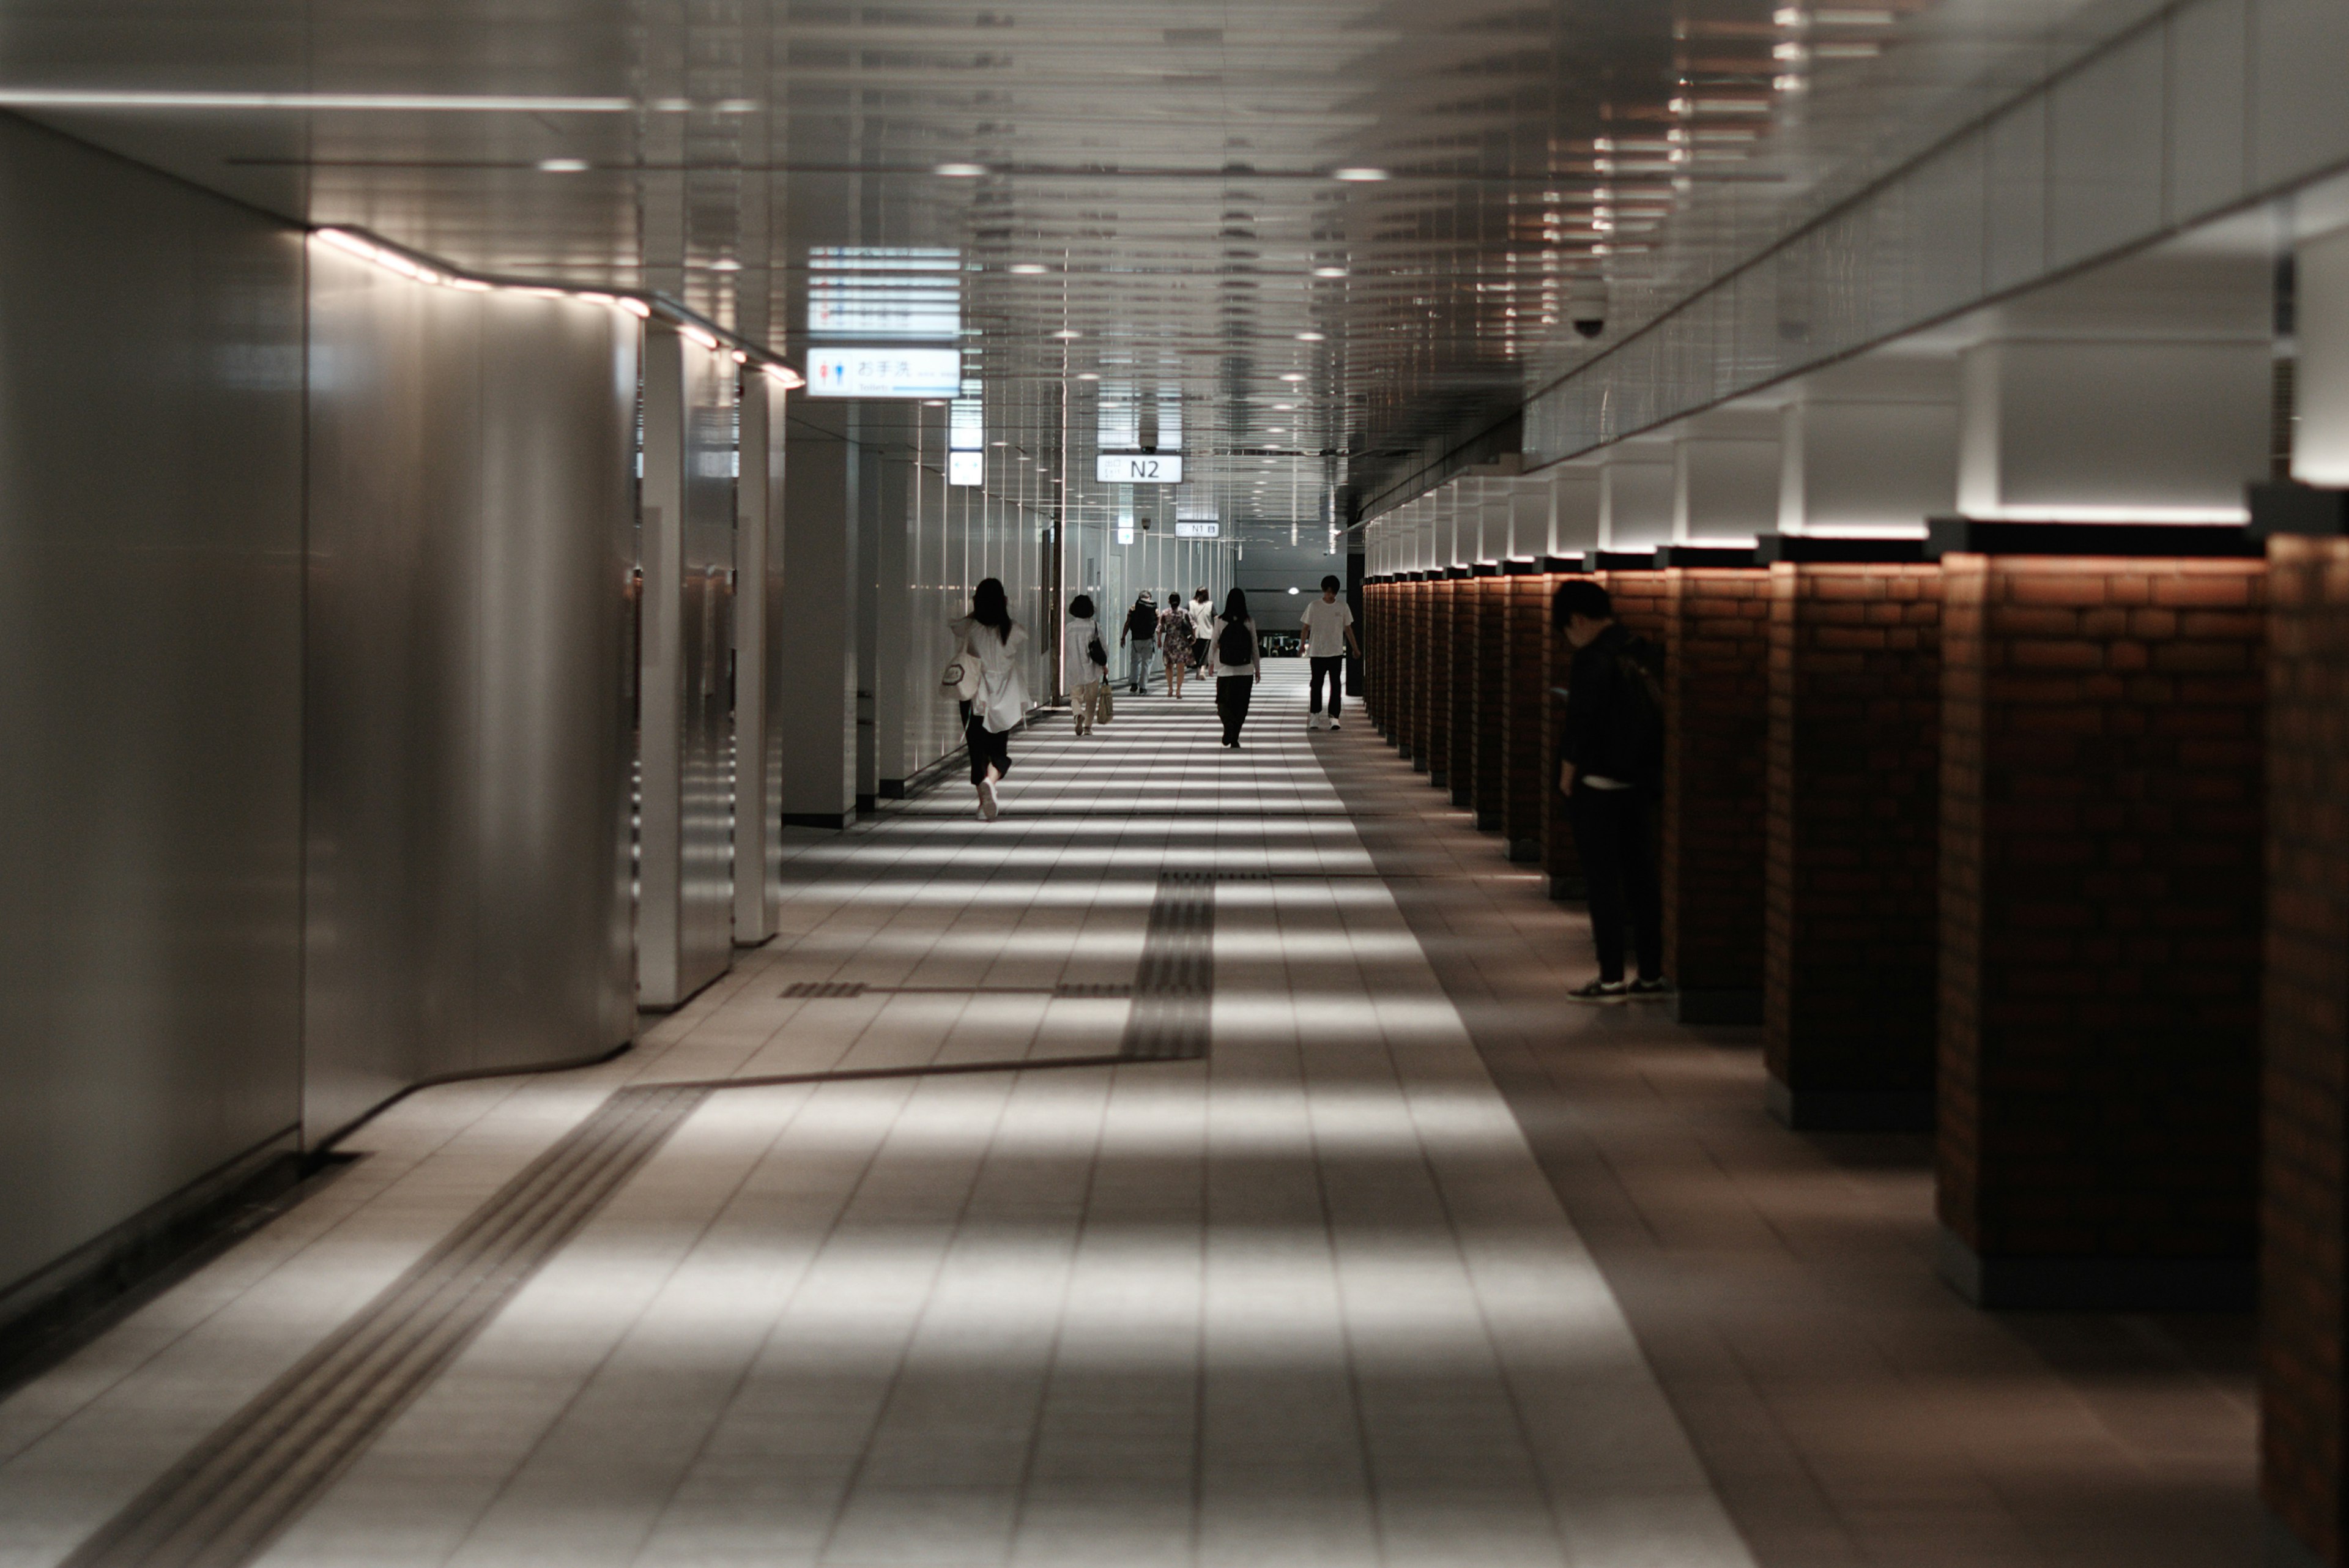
[66,1086,707,1568]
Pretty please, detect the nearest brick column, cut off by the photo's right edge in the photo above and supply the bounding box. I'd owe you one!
[2260,538,2349,1563]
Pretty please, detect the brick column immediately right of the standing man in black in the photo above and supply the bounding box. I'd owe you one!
[1658,545,1769,1023]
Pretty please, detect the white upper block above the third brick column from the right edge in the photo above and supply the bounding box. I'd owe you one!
[1778,355,1957,536]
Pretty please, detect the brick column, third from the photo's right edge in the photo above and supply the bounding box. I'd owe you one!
[1762,536,1940,1128]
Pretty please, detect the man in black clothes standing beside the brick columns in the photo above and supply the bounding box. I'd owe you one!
[1550,583,1670,1001]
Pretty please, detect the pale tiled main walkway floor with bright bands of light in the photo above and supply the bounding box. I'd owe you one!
[0,667,1747,1568]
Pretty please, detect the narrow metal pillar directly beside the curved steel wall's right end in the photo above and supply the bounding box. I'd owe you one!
[637,322,735,1008]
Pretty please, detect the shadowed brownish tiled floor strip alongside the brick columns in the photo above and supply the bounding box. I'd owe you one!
[1315,700,2260,1568]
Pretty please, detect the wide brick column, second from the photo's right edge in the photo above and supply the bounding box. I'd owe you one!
[1935,522,2267,1309]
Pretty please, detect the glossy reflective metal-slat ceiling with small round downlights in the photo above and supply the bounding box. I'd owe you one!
[0,0,2147,527]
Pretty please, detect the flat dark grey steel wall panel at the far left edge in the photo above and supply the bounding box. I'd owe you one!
[0,117,301,1286]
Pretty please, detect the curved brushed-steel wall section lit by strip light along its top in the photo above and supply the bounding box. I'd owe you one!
[303,245,637,1138]
